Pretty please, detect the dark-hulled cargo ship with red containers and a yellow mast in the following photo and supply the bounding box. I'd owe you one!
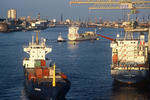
[23,32,71,100]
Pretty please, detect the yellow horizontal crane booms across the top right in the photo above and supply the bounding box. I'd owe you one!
[70,0,150,10]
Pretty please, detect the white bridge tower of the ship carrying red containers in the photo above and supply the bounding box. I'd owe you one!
[23,33,52,68]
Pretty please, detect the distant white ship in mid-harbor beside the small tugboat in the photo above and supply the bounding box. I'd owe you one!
[68,26,98,41]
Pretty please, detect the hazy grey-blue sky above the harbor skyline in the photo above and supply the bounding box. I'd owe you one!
[0,0,150,21]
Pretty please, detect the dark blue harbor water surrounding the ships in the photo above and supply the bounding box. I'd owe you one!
[0,28,150,100]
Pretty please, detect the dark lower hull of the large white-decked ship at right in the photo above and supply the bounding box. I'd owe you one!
[111,69,149,84]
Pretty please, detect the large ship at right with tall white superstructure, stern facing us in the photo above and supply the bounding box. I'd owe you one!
[110,23,150,84]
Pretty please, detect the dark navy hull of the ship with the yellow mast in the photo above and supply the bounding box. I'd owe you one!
[25,79,71,100]
